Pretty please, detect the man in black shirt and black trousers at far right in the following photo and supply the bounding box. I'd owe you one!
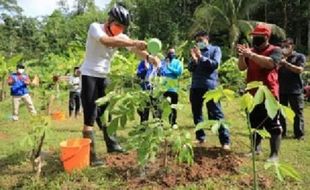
[279,38,306,140]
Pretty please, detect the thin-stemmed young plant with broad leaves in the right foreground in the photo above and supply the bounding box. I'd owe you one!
[196,82,300,189]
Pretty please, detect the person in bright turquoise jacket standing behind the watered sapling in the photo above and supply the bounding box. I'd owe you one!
[160,48,183,129]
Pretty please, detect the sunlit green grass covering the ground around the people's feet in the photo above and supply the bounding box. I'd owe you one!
[0,91,310,190]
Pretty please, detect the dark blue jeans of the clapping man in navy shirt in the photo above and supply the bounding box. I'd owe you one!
[190,88,230,145]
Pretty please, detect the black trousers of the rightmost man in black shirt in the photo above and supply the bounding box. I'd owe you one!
[280,94,304,138]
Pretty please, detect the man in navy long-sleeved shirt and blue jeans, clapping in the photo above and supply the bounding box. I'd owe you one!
[188,31,230,150]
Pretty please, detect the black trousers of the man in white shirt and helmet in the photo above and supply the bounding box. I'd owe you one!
[81,75,108,126]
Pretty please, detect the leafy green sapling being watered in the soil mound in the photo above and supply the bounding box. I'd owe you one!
[96,51,193,174]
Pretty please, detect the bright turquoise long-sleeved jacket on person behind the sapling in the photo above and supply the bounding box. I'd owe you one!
[160,58,183,92]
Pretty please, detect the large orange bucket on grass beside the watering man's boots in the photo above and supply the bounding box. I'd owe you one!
[60,138,91,173]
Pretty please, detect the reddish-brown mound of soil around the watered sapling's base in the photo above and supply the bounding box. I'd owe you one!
[105,146,243,189]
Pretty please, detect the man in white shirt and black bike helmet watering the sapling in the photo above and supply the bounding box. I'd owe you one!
[80,4,160,166]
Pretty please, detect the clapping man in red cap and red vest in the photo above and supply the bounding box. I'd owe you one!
[237,23,282,161]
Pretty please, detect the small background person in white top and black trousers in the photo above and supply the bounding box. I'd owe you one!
[68,67,81,118]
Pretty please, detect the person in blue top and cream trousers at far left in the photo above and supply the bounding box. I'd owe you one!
[8,63,37,121]
